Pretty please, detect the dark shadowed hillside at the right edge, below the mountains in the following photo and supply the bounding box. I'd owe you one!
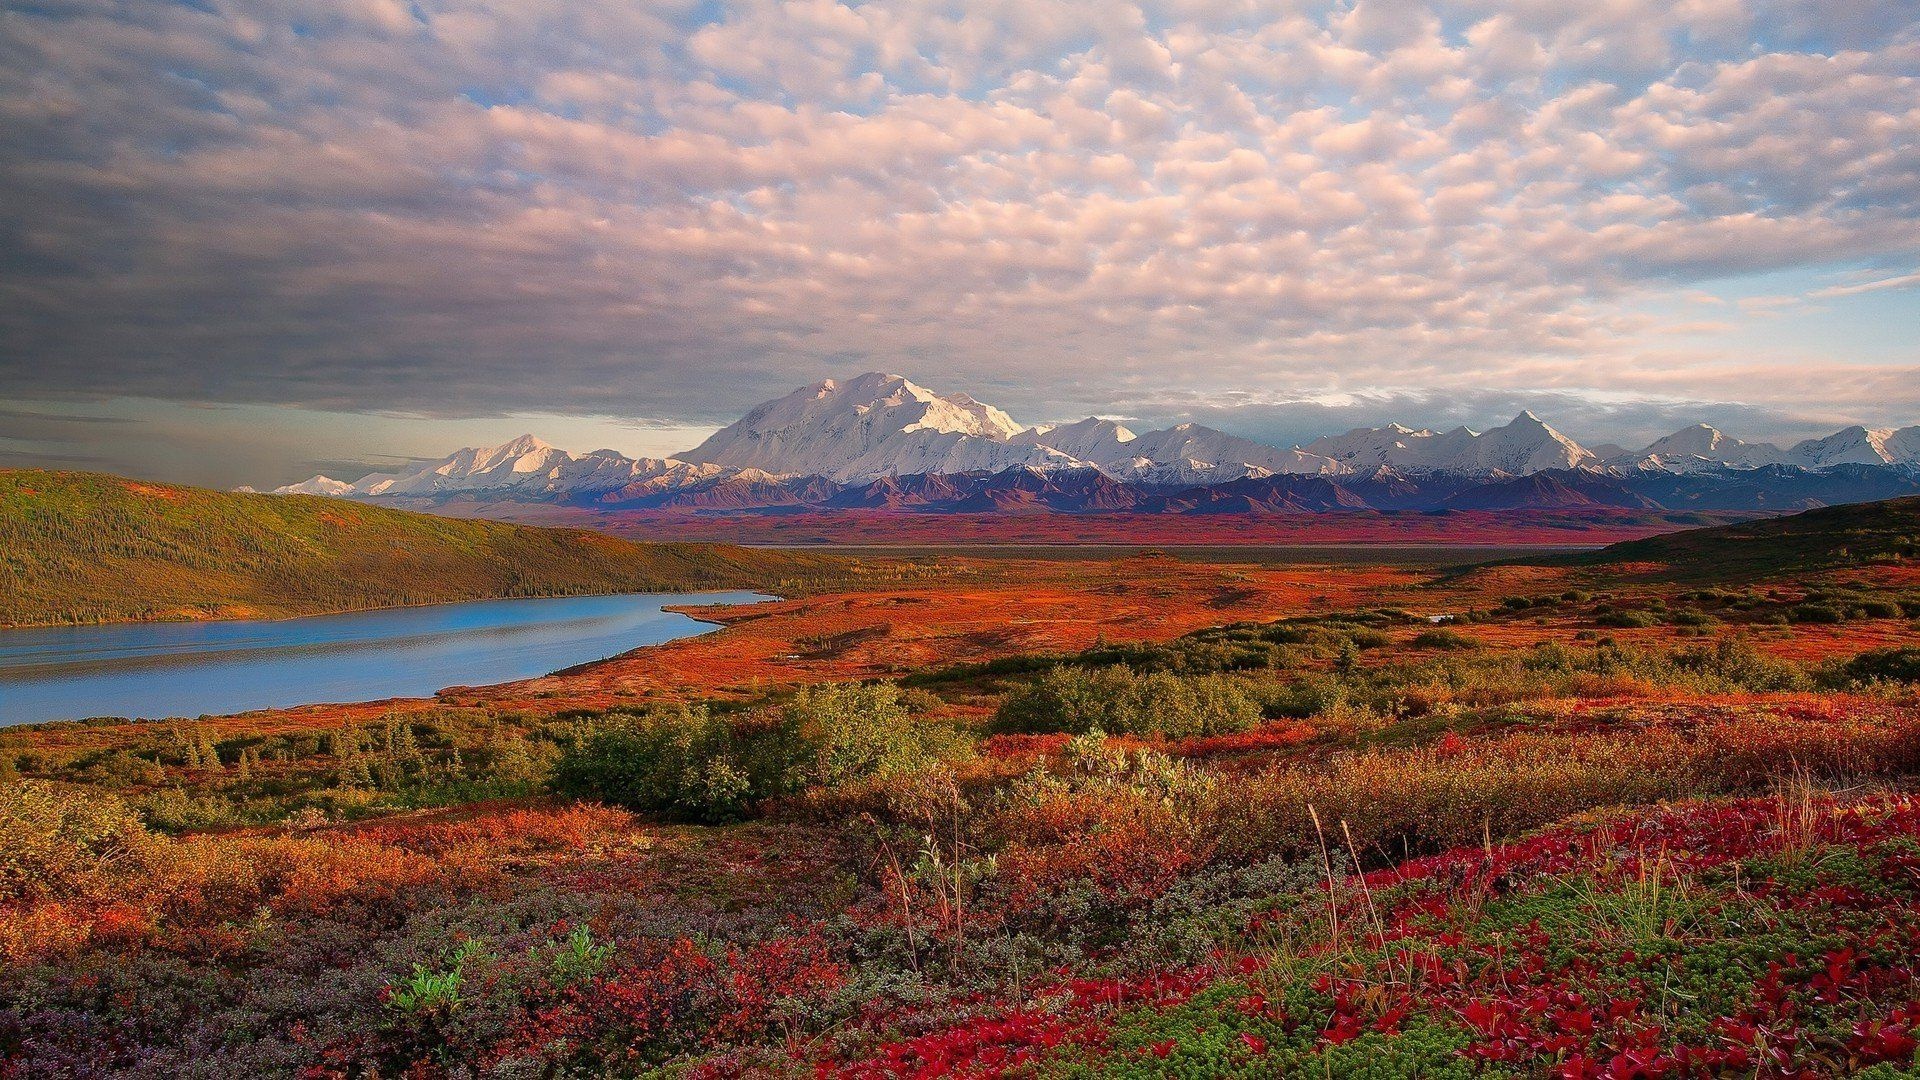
[1548,496,1920,580]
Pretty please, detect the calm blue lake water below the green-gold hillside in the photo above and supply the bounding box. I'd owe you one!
[0,592,770,726]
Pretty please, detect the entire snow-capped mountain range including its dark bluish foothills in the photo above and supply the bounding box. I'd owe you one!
[276,373,1920,513]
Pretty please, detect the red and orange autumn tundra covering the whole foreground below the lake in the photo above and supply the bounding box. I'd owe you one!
[0,500,1920,1078]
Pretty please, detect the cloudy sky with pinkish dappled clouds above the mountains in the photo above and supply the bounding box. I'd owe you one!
[0,0,1920,486]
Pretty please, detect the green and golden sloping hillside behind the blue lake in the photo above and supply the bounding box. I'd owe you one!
[0,471,843,625]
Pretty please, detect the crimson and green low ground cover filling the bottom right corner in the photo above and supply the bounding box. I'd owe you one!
[818,796,1920,1080]
